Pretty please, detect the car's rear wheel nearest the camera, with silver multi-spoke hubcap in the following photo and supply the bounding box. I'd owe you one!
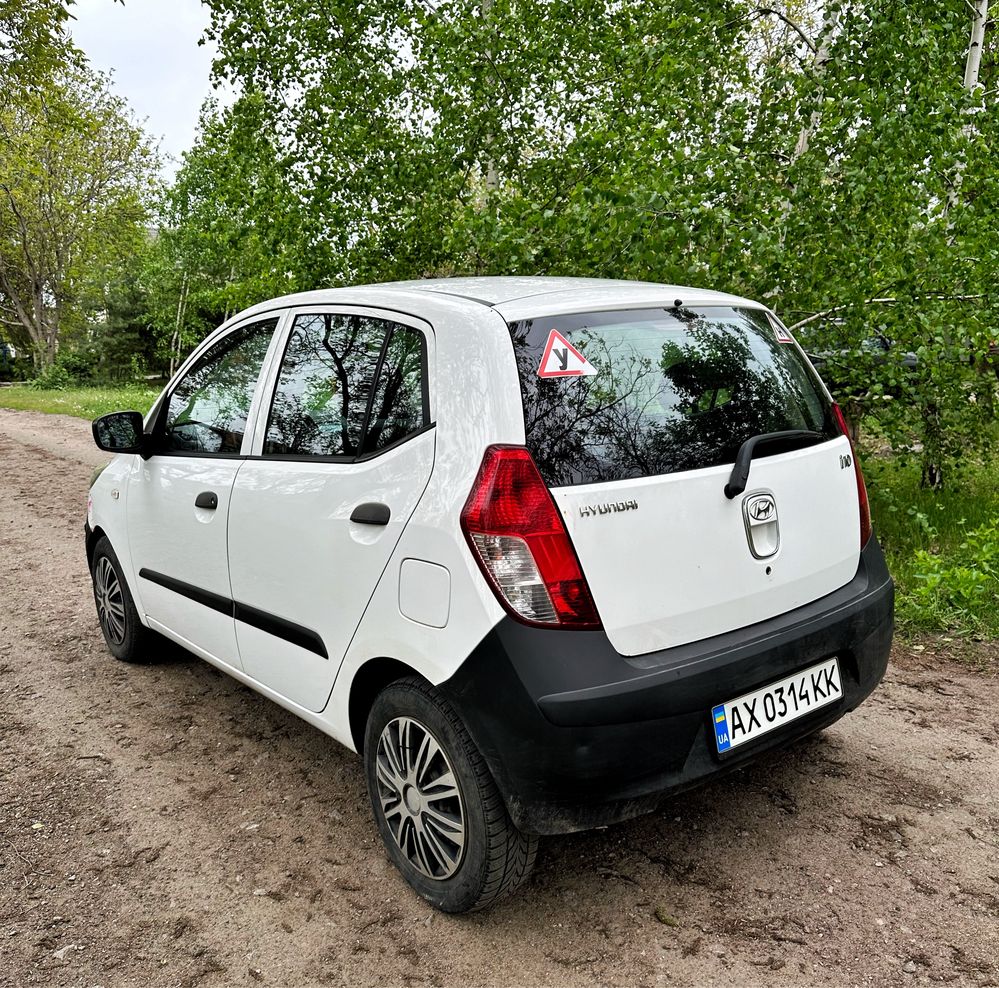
[364,678,538,913]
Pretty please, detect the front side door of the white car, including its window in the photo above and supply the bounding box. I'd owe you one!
[126,317,278,669]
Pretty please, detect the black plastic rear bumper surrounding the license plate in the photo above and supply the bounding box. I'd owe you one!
[440,539,894,834]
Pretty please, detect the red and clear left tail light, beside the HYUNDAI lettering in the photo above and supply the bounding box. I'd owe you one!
[461,446,600,628]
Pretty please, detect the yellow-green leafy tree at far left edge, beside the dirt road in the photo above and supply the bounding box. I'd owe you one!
[0,68,155,369]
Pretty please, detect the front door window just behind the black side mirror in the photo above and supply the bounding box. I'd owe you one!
[162,318,278,454]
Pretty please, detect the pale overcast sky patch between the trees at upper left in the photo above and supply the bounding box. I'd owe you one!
[70,0,221,177]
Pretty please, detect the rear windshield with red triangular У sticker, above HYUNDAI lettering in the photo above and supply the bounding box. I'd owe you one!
[510,306,838,487]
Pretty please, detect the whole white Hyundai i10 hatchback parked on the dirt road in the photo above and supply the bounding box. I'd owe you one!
[86,278,893,912]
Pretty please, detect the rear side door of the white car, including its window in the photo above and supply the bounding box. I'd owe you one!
[229,307,434,711]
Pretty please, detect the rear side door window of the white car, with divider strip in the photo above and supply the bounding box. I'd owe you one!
[264,313,427,458]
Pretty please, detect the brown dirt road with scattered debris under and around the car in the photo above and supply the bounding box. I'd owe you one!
[0,411,999,988]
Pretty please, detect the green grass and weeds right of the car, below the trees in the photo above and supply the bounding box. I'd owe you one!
[864,448,999,639]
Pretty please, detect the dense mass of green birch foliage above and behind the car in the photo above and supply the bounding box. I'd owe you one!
[168,0,999,477]
